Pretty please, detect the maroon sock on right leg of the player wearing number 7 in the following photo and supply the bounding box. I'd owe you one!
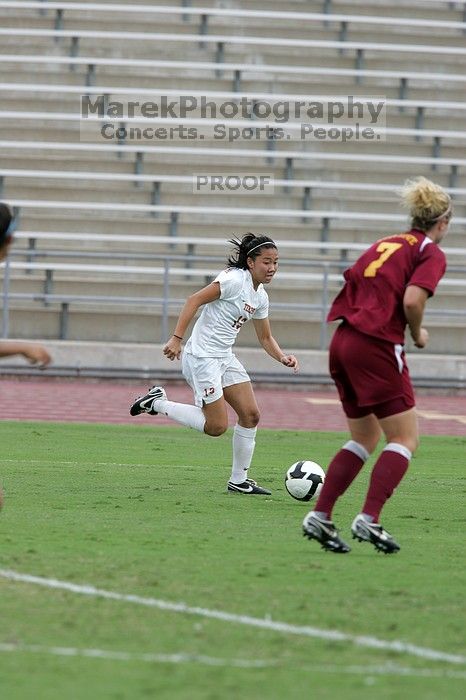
[362,449,409,522]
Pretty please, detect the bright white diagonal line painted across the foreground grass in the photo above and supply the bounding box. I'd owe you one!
[0,569,466,664]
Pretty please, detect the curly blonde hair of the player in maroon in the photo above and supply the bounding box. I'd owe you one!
[400,175,451,231]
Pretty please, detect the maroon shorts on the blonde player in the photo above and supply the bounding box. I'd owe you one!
[329,323,415,418]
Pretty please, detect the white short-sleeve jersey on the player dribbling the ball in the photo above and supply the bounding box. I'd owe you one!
[185,267,269,357]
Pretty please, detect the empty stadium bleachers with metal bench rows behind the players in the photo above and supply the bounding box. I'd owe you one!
[0,0,466,354]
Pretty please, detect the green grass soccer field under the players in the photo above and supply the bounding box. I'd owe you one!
[0,422,466,700]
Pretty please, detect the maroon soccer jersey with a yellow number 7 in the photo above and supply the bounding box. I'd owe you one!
[327,229,446,343]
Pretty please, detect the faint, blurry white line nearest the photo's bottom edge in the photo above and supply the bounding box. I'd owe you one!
[0,643,466,679]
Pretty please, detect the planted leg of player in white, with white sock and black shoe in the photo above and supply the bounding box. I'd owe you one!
[223,381,270,495]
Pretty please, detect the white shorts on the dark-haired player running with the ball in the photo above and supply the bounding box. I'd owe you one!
[181,351,251,408]
